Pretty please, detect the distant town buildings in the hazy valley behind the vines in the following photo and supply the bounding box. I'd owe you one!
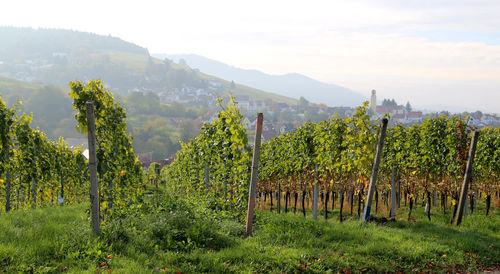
[151,84,500,140]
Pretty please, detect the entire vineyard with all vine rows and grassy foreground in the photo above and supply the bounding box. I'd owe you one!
[0,83,500,272]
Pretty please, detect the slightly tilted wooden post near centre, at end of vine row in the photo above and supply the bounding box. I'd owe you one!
[245,113,264,237]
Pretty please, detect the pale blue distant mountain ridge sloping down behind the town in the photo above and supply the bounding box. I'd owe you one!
[153,54,367,106]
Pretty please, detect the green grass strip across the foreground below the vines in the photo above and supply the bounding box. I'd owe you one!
[0,194,500,273]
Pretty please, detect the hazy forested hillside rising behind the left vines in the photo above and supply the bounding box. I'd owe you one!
[0,27,296,160]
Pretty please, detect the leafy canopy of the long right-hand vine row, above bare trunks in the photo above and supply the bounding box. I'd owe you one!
[258,103,500,218]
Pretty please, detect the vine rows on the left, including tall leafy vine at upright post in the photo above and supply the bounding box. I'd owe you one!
[0,81,143,220]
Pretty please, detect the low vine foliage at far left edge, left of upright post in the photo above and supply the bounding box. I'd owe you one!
[0,93,88,211]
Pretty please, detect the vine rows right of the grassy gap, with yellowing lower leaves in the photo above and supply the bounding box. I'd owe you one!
[162,101,500,225]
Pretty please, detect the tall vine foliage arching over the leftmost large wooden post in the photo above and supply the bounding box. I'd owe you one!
[69,80,144,221]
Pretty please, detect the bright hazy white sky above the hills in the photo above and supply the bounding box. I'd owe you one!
[0,0,500,113]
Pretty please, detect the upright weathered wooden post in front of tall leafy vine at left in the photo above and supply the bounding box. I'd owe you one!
[86,102,101,235]
